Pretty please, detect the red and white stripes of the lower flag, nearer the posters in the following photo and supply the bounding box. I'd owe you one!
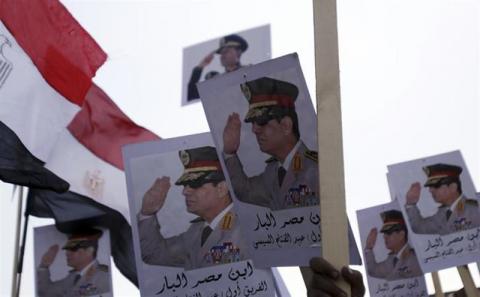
[45,84,160,221]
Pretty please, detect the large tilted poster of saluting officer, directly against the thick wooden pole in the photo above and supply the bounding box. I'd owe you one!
[198,54,359,266]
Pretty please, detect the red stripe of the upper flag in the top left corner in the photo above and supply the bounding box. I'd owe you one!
[0,0,107,106]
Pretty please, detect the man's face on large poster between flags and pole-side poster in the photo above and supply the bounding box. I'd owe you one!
[183,183,220,217]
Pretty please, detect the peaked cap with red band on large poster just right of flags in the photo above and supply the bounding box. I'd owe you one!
[175,146,225,188]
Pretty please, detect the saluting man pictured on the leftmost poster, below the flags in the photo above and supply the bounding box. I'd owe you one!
[37,229,110,297]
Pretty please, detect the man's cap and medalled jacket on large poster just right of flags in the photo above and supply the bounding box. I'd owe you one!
[138,147,250,269]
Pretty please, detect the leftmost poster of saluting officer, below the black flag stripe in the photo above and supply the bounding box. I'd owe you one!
[34,225,113,297]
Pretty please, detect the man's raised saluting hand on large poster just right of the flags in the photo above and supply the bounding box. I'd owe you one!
[141,176,170,216]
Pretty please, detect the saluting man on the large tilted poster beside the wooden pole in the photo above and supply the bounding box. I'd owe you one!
[223,77,319,210]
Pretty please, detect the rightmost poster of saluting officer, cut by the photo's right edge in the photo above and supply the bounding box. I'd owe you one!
[388,151,480,272]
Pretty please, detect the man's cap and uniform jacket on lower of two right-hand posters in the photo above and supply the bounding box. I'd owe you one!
[365,210,423,281]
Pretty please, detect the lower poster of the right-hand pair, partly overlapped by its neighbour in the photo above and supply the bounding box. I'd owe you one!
[357,200,428,297]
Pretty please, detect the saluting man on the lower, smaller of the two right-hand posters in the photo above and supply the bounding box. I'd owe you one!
[365,210,423,281]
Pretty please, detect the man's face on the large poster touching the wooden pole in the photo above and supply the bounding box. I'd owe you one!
[252,119,285,155]
